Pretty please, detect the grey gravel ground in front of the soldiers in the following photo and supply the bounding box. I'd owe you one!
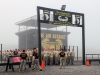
[0,65,100,75]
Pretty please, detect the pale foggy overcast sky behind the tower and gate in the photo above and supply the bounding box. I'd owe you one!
[0,0,100,55]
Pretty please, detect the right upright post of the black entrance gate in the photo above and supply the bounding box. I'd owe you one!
[82,15,85,65]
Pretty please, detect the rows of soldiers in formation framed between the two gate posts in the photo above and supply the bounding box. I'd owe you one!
[42,49,75,65]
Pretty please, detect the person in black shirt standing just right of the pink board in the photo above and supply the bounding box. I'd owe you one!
[19,50,28,72]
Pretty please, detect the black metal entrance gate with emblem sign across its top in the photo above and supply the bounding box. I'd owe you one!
[37,6,85,65]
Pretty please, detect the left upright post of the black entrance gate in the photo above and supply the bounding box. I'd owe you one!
[37,7,41,65]
